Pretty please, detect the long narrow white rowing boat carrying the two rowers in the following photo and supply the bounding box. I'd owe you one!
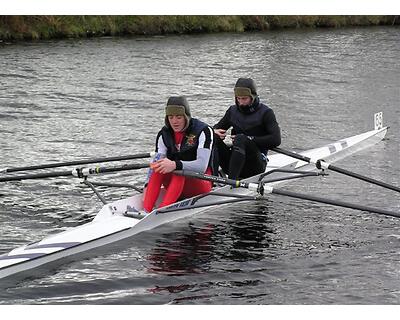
[0,112,396,280]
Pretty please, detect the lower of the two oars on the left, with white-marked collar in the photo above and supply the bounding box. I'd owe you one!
[0,163,149,182]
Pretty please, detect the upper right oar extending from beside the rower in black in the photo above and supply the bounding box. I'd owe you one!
[271,148,400,192]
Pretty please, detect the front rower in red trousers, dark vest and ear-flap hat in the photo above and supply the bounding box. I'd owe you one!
[143,96,213,212]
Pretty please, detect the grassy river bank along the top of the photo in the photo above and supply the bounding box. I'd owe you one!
[0,16,400,40]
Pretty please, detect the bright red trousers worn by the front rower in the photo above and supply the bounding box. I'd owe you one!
[143,168,212,212]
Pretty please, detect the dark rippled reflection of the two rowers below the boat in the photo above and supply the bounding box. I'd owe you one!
[146,210,276,303]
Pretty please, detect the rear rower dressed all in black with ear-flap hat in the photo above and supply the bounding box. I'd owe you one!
[214,78,281,180]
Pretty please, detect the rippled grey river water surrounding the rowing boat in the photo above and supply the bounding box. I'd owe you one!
[0,27,400,304]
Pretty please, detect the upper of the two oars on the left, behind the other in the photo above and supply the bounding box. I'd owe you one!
[0,152,155,173]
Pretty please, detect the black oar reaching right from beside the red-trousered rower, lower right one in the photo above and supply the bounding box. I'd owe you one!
[174,170,400,218]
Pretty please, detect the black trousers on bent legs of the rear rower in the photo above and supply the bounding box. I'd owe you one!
[215,134,267,180]
